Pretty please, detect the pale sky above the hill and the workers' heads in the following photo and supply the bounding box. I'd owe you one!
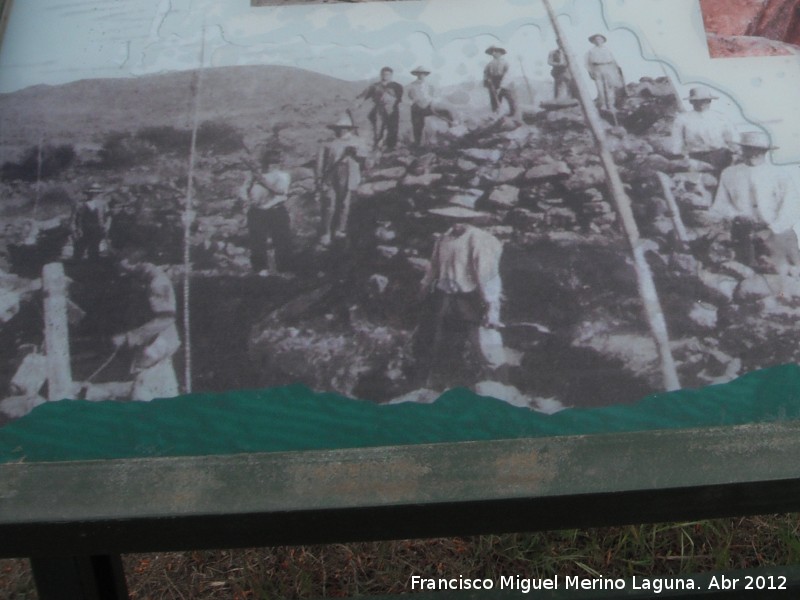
[0,0,800,162]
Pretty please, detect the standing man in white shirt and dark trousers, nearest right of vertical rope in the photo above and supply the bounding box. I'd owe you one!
[245,149,292,277]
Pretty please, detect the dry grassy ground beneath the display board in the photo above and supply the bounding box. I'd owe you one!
[0,514,800,600]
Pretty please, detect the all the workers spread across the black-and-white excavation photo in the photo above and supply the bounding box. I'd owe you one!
[54,34,800,399]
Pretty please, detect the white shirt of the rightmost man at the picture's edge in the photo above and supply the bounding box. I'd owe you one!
[709,163,800,233]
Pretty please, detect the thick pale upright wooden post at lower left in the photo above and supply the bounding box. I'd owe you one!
[42,263,72,400]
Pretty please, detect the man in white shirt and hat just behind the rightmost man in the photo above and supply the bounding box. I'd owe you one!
[670,87,738,177]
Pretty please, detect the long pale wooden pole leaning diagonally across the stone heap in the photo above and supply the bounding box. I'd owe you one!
[542,0,681,390]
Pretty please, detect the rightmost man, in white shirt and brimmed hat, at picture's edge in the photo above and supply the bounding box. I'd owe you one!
[709,131,800,273]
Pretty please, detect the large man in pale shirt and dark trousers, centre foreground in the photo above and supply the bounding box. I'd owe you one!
[415,216,505,387]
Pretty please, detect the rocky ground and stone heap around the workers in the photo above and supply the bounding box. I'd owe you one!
[0,74,800,417]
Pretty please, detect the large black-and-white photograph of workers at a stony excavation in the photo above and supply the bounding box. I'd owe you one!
[0,0,800,424]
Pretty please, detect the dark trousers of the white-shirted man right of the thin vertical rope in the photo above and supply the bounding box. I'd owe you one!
[247,204,292,271]
